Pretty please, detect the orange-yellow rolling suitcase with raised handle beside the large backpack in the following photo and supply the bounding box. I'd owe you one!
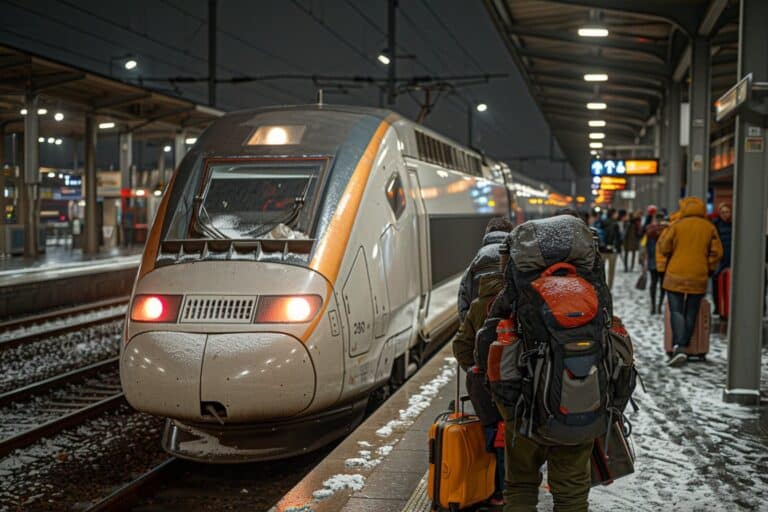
[427,369,496,511]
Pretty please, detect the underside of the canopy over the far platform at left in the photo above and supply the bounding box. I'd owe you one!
[0,45,223,139]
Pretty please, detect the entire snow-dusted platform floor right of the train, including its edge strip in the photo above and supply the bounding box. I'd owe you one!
[272,271,768,512]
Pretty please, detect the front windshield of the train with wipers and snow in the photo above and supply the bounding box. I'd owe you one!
[172,161,319,240]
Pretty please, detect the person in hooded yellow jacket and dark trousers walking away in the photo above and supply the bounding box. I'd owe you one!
[656,197,723,366]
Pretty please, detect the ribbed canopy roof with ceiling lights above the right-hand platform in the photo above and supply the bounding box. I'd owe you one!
[485,0,739,174]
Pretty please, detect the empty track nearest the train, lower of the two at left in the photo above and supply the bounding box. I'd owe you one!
[0,357,125,457]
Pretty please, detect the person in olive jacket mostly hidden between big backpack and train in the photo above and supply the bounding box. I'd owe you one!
[451,272,504,506]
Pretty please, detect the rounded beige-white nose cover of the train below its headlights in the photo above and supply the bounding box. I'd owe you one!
[120,332,316,423]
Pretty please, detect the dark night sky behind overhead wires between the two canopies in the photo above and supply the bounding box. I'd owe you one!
[0,0,571,191]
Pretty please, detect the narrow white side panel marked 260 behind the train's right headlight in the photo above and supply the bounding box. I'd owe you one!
[341,246,373,357]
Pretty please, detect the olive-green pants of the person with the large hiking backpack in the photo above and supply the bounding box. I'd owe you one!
[504,421,593,512]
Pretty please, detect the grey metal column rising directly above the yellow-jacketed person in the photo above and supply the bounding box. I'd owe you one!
[686,37,712,202]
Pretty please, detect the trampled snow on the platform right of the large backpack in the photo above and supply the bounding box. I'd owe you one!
[584,270,768,512]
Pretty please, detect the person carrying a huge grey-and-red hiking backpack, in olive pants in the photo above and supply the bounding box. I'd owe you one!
[484,212,636,512]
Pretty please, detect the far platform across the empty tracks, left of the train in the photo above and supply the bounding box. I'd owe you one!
[0,247,142,318]
